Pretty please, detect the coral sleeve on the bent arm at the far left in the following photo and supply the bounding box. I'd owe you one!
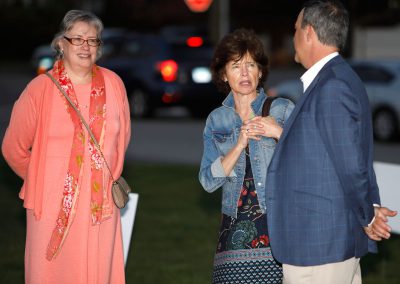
[1,85,37,179]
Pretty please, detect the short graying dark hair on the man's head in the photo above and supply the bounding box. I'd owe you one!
[301,0,349,50]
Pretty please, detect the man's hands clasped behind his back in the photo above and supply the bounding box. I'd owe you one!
[364,207,397,241]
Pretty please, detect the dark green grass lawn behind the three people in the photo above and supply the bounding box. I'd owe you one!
[0,160,400,284]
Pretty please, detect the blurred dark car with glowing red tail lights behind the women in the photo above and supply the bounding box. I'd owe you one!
[32,28,223,117]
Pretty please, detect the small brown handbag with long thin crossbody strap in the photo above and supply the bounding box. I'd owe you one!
[46,72,132,209]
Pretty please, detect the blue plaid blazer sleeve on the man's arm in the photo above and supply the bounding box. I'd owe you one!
[315,79,374,226]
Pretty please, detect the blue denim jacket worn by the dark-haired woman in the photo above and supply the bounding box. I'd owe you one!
[199,89,294,218]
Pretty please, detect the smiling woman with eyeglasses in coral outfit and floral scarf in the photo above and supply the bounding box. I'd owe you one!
[2,10,131,284]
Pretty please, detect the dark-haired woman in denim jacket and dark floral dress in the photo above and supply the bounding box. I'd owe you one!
[199,29,294,284]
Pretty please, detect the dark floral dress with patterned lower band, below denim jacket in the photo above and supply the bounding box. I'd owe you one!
[212,156,283,284]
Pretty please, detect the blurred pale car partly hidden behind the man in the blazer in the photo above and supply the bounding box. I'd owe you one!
[269,60,400,141]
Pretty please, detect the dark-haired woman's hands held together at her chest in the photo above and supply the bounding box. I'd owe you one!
[241,116,283,140]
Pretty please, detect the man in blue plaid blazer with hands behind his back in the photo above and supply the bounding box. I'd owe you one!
[266,0,396,284]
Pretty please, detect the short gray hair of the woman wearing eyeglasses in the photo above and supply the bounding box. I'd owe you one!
[51,10,103,59]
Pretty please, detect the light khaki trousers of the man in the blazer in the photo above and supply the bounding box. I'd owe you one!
[282,257,361,284]
